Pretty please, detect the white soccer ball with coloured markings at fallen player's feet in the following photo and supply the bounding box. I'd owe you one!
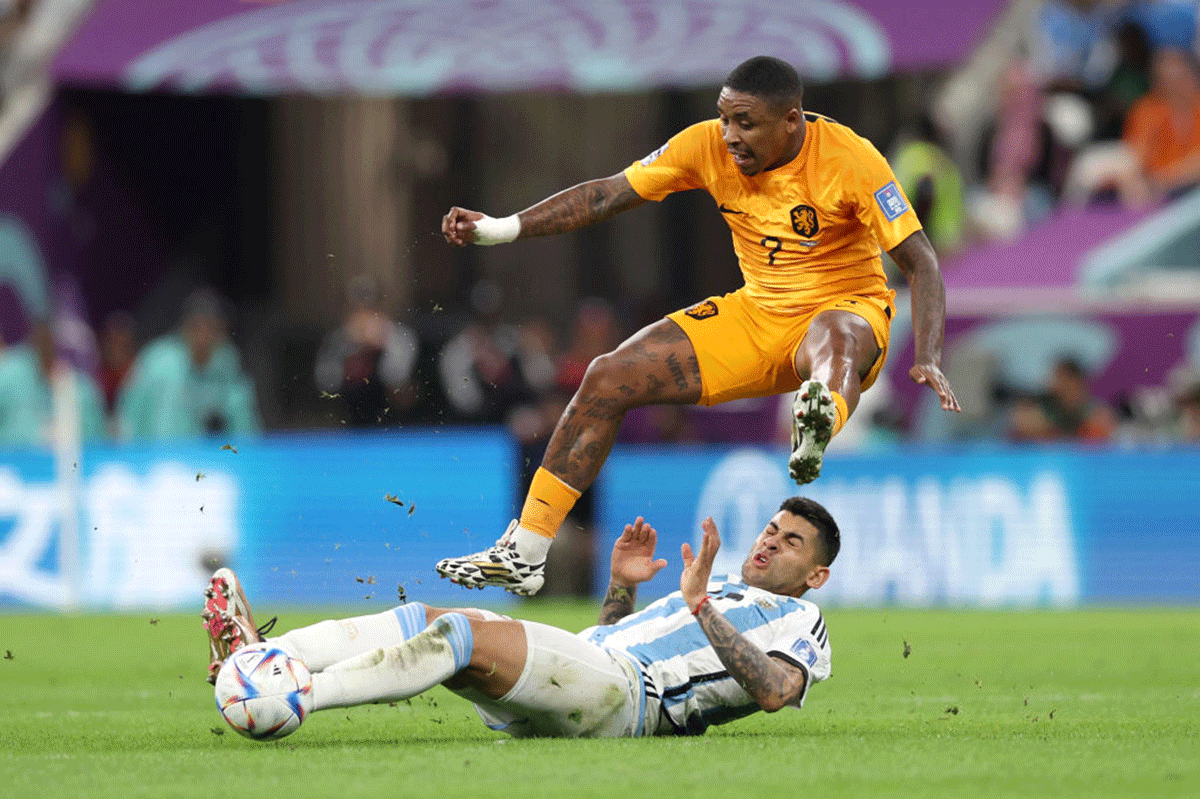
[216,643,312,740]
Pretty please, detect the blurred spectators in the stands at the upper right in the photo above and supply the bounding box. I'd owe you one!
[889,0,1200,245]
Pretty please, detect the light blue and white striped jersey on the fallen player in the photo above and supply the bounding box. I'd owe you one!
[578,575,832,734]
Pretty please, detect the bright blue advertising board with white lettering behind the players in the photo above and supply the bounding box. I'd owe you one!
[0,429,1200,609]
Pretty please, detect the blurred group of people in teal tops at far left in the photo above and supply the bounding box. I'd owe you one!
[0,289,262,446]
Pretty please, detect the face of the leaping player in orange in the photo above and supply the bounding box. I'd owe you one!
[716,86,804,175]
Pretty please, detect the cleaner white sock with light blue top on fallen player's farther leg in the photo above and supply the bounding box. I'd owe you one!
[270,602,428,672]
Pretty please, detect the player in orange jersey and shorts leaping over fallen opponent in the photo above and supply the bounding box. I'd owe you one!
[437,56,959,594]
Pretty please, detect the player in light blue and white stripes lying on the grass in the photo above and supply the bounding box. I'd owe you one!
[204,497,840,738]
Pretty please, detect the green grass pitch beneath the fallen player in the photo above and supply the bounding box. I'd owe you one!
[0,603,1200,799]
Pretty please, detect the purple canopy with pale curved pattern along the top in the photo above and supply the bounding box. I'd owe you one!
[55,0,1007,95]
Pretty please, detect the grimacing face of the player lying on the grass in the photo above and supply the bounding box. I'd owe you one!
[742,511,829,596]
